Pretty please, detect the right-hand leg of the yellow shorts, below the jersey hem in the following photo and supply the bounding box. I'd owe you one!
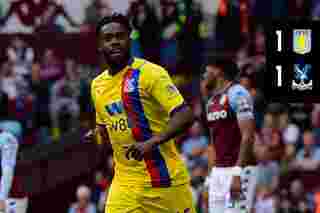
[141,184,196,213]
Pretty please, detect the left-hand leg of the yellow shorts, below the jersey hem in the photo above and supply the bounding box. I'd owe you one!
[105,183,144,213]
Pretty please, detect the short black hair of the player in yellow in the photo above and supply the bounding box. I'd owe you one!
[96,13,132,36]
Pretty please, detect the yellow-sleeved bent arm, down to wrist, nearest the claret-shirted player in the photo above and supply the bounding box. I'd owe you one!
[151,70,194,144]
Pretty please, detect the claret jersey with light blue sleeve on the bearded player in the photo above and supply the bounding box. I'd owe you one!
[206,84,254,167]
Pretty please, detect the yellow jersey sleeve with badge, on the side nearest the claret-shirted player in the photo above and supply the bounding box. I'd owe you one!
[150,68,185,115]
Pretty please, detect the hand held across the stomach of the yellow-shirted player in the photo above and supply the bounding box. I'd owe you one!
[126,137,158,161]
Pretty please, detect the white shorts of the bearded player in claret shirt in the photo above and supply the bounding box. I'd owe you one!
[208,166,257,213]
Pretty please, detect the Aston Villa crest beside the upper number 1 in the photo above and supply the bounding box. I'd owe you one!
[293,29,311,55]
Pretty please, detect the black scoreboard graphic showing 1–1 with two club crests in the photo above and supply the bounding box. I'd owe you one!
[264,21,320,103]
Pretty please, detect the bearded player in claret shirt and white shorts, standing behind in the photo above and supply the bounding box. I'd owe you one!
[202,56,257,213]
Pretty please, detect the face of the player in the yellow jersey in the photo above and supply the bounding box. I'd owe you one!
[99,23,130,64]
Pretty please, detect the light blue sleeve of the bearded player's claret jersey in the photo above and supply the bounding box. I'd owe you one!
[229,86,254,120]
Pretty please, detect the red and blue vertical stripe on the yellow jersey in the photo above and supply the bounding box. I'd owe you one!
[122,69,171,187]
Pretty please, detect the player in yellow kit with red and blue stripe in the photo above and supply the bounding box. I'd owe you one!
[87,14,195,213]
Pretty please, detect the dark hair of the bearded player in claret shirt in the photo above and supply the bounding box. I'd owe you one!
[206,54,240,81]
